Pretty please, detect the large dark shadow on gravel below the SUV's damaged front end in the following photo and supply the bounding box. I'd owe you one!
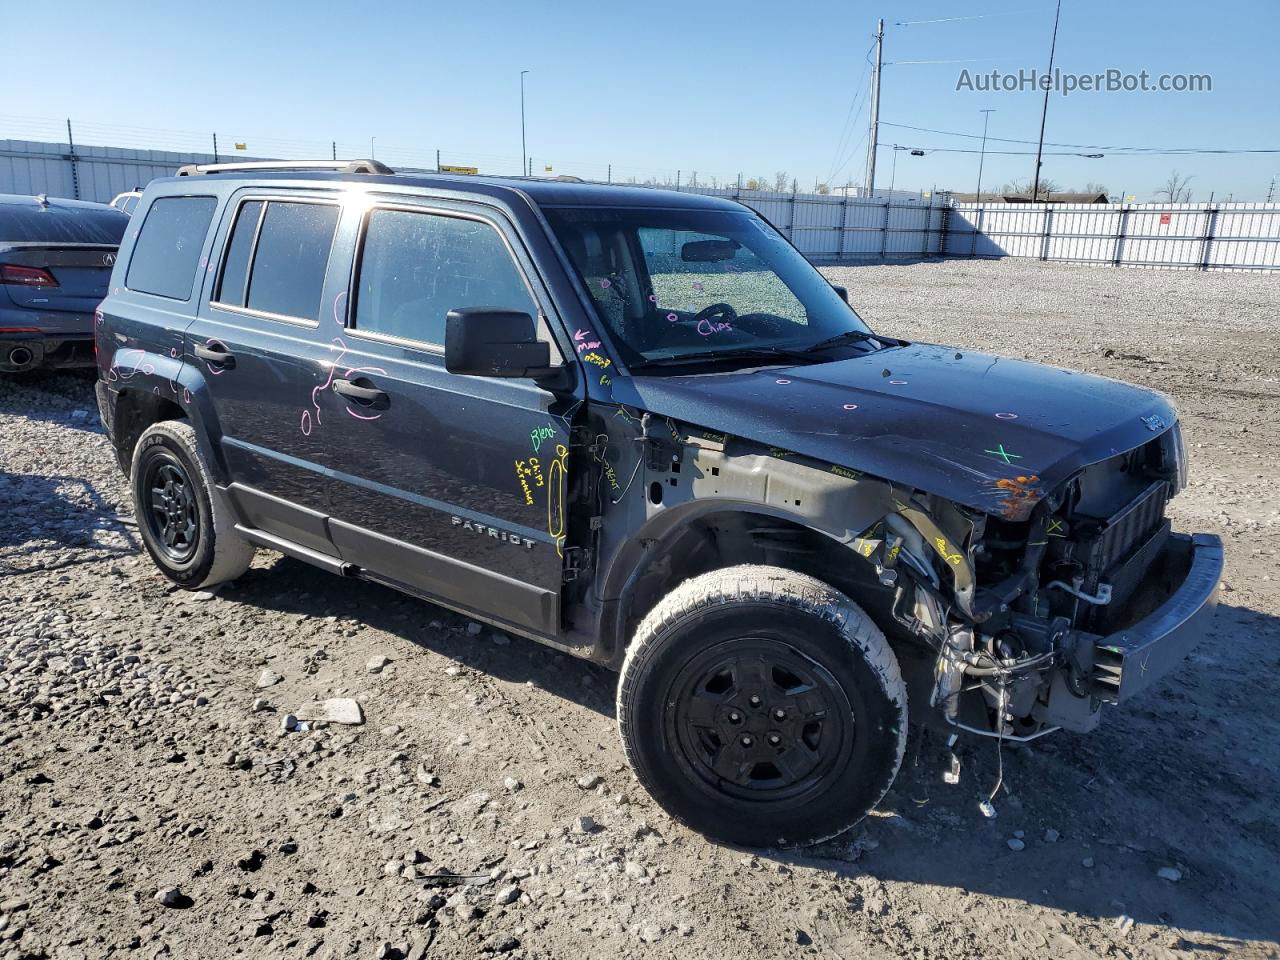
[769,605,1280,955]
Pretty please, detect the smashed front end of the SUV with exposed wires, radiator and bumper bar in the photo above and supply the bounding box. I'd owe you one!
[861,425,1222,757]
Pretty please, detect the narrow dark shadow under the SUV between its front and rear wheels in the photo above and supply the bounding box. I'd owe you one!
[220,557,617,717]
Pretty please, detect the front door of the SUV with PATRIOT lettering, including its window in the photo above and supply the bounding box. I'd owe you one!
[316,205,573,636]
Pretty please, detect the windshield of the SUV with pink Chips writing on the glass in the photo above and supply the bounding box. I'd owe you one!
[545,207,868,366]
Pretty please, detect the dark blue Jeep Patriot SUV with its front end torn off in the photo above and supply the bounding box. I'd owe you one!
[96,161,1222,845]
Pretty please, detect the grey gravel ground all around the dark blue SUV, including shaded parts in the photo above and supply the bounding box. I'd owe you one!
[0,260,1280,960]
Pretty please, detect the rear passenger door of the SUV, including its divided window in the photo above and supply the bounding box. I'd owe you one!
[186,189,342,556]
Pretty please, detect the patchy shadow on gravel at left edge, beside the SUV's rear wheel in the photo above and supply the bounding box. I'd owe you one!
[0,470,140,575]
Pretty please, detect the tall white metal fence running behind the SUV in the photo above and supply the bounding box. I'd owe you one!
[0,140,1280,270]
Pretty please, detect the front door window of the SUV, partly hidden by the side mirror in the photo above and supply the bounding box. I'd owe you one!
[355,210,538,344]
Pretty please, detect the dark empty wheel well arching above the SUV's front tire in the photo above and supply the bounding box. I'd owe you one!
[616,511,891,655]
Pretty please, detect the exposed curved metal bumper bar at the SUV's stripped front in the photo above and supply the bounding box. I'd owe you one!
[1089,534,1222,703]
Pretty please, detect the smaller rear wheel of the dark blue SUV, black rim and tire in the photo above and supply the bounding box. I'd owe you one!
[129,420,253,590]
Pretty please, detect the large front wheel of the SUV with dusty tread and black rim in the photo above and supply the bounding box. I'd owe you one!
[617,566,906,846]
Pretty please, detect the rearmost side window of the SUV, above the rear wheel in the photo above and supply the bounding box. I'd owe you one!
[124,197,218,300]
